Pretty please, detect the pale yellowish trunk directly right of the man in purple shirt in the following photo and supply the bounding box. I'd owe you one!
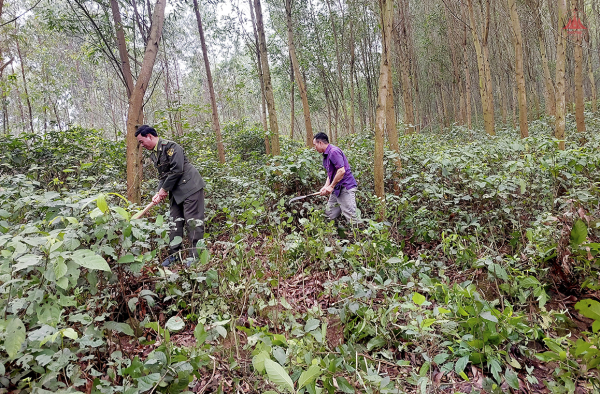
[373,0,393,208]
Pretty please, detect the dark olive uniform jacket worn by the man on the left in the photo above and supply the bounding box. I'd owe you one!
[150,138,206,204]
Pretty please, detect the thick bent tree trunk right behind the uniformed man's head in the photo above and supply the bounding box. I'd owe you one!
[127,0,167,203]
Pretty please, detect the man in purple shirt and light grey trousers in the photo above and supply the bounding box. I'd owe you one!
[313,133,357,223]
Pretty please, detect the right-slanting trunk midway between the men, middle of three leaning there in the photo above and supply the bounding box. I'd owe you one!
[254,0,281,156]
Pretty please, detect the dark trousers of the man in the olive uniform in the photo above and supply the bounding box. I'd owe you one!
[169,189,204,258]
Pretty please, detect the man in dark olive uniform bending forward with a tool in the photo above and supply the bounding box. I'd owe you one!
[135,125,206,267]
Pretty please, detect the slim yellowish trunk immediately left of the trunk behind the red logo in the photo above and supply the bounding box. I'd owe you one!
[554,0,567,150]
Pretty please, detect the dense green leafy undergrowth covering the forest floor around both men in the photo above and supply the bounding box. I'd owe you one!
[0,114,600,394]
